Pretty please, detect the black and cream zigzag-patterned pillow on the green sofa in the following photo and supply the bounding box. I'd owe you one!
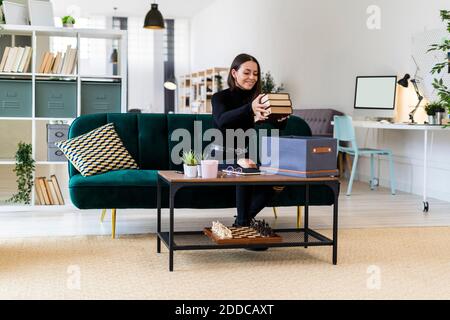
[55,123,139,177]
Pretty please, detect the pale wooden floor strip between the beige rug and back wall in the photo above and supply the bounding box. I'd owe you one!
[0,182,450,238]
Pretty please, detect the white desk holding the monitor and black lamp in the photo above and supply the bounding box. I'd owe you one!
[353,120,450,212]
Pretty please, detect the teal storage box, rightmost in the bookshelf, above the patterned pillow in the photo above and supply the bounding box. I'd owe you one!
[81,81,122,115]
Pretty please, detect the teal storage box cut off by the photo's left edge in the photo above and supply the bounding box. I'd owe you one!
[0,79,32,117]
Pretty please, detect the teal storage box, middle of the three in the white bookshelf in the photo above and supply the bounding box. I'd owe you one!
[36,80,77,118]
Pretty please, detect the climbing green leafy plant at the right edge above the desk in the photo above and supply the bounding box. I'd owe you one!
[427,10,450,112]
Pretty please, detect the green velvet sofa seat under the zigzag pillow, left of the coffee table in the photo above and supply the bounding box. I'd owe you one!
[69,170,158,188]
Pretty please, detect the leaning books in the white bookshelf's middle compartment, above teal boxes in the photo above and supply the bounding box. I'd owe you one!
[37,45,77,74]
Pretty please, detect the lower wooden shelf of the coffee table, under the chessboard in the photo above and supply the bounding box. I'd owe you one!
[158,229,333,250]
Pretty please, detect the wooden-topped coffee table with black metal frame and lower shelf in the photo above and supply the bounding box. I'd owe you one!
[157,171,340,272]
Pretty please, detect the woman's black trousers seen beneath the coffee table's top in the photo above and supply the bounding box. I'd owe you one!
[236,186,275,226]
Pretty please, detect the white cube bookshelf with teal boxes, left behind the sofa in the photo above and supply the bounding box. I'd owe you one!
[0,24,128,211]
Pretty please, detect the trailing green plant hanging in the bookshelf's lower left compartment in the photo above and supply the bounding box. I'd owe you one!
[7,142,35,204]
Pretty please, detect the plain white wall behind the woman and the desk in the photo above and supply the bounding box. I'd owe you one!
[191,0,450,201]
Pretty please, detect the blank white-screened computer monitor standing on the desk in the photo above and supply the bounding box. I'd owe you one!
[353,76,397,120]
